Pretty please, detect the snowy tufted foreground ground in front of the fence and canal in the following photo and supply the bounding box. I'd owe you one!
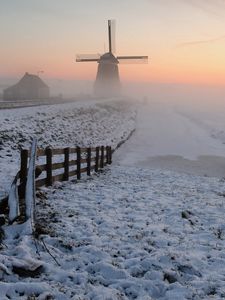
[0,166,225,300]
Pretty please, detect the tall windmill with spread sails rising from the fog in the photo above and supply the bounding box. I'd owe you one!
[76,20,148,96]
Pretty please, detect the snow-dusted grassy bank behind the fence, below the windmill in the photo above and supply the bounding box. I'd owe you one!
[0,99,135,196]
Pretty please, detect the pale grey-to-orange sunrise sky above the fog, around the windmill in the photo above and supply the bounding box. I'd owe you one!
[0,0,225,86]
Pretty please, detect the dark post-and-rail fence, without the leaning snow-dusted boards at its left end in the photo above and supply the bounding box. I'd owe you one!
[20,146,112,187]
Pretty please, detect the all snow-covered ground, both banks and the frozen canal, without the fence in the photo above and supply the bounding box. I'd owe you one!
[0,97,225,300]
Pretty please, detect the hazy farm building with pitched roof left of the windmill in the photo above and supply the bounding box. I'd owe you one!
[3,73,49,100]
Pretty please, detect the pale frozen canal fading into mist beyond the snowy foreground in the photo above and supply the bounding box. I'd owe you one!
[114,101,225,177]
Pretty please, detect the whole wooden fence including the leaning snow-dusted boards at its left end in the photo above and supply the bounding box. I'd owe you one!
[8,139,113,227]
